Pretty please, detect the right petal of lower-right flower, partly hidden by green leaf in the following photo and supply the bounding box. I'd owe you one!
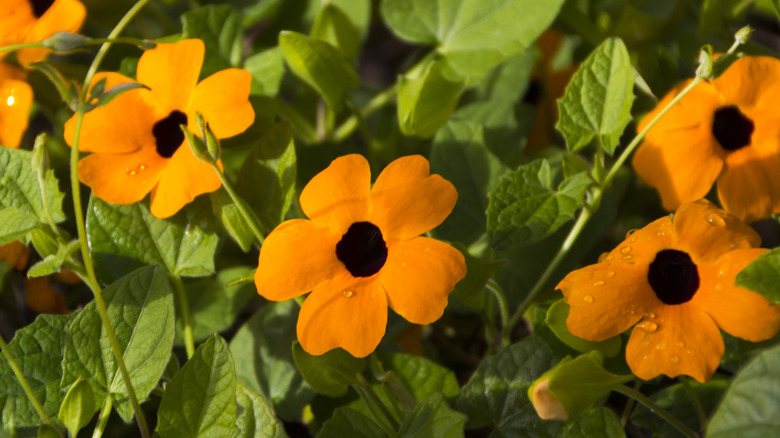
[690,248,780,342]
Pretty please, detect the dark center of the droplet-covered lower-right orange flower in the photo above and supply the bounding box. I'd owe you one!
[647,249,699,304]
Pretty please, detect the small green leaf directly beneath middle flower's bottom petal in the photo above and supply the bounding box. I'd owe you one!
[292,342,366,397]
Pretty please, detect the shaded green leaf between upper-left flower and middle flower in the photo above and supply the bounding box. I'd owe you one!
[236,123,297,235]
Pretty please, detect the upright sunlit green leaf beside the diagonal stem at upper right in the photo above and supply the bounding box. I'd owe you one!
[555,38,634,155]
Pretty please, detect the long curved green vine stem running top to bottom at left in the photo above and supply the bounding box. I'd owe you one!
[70,0,149,438]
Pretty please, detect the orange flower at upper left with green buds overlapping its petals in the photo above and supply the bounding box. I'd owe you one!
[65,39,255,218]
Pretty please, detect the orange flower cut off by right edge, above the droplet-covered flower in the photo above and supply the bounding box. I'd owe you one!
[633,56,780,222]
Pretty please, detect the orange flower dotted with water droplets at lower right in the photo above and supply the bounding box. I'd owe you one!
[556,201,780,382]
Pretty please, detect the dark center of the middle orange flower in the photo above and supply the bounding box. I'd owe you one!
[336,222,387,277]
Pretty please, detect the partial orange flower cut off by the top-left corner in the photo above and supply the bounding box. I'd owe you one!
[0,0,87,65]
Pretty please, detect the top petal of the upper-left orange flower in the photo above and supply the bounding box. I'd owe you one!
[136,39,206,119]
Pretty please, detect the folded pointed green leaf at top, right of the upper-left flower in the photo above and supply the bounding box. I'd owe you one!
[279,31,360,109]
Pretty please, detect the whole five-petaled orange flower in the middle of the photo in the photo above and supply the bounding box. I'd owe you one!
[255,155,466,357]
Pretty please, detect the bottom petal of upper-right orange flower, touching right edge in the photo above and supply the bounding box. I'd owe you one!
[718,148,780,223]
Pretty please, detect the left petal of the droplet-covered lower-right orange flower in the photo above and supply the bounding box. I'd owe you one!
[555,261,661,341]
